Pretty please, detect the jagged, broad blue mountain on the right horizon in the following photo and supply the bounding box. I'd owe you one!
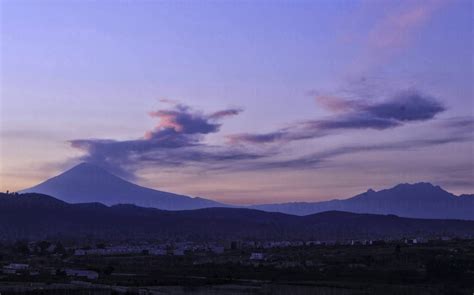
[250,182,474,220]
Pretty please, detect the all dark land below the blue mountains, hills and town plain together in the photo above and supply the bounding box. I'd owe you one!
[0,194,474,295]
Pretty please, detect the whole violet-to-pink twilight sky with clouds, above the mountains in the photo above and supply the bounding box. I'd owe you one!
[0,0,474,204]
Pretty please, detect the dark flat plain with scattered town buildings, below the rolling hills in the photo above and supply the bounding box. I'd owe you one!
[0,240,474,295]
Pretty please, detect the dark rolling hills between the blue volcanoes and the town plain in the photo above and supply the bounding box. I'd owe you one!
[0,194,474,241]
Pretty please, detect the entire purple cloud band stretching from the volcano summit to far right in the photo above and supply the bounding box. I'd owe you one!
[70,98,462,179]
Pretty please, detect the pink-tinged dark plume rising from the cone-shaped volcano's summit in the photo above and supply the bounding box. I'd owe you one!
[69,101,250,179]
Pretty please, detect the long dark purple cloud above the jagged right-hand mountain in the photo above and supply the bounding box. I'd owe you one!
[229,90,446,144]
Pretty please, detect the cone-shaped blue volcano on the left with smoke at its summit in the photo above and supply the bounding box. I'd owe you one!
[21,163,227,210]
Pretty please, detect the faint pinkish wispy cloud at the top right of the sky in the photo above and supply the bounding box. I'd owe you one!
[345,0,446,76]
